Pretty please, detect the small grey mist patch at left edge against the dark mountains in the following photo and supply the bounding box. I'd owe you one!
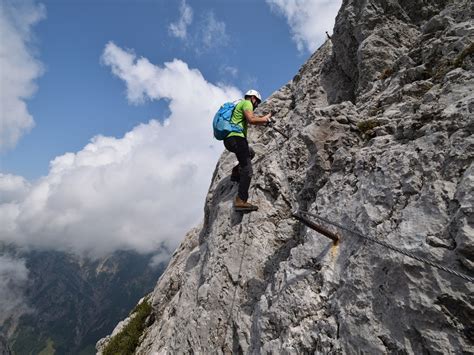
[0,255,29,324]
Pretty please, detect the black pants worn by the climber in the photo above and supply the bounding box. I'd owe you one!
[224,137,255,201]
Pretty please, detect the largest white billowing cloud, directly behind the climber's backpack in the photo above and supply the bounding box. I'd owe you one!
[0,43,242,262]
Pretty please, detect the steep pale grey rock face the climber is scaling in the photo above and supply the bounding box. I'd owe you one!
[98,0,474,354]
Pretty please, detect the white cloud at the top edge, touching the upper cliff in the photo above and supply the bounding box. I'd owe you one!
[266,0,342,52]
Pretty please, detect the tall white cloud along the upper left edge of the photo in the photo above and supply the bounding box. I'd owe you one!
[0,1,46,150]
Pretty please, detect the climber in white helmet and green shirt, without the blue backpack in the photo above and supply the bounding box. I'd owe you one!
[224,90,271,212]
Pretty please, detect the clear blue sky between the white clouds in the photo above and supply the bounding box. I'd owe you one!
[1,0,336,179]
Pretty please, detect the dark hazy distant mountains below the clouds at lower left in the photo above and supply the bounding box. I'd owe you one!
[0,248,163,355]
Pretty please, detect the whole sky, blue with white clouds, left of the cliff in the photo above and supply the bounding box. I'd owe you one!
[0,0,340,260]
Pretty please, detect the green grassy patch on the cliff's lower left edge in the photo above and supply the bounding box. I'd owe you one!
[103,299,152,355]
